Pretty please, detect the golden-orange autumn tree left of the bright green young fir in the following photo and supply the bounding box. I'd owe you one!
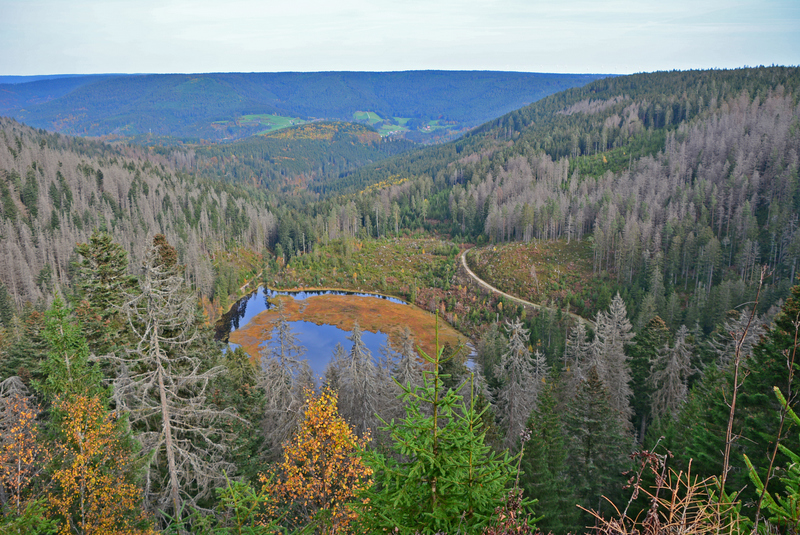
[260,389,372,533]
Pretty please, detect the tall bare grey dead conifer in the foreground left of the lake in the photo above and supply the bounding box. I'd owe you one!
[111,237,236,520]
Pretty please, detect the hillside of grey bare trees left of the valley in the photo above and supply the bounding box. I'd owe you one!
[0,119,277,305]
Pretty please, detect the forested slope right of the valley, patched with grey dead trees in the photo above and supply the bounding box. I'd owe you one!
[306,67,800,326]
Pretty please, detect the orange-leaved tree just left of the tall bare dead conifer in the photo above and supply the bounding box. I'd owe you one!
[47,395,154,535]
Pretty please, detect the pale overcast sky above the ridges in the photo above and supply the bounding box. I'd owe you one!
[0,0,800,75]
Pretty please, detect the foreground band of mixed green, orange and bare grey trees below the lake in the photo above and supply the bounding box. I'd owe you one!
[0,233,800,535]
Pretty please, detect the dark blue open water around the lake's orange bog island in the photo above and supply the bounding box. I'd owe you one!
[216,287,405,377]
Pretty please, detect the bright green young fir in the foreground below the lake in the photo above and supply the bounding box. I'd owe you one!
[361,328,514,534]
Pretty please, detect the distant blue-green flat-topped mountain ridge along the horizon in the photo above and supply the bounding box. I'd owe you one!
[0,71,605,141]
